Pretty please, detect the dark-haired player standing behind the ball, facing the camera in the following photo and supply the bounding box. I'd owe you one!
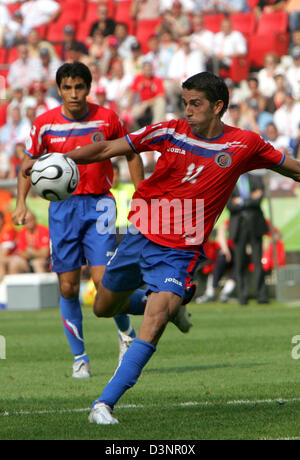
[13,62,143,378]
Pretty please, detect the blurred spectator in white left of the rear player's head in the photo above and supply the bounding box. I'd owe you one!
[7,43,42,91]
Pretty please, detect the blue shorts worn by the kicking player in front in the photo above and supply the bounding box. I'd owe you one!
[102,228,205,297]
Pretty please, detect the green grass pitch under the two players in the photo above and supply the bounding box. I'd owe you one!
[0,301,300,440]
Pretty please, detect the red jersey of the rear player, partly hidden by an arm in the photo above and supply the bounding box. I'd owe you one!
[26,103,127,195]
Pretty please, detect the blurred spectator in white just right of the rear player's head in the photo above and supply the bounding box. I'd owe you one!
[99,59,133,115]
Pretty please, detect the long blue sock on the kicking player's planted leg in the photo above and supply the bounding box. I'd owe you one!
[92,339,156,408]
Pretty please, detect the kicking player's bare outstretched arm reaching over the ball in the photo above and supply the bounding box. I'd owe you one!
[68,137,133,165]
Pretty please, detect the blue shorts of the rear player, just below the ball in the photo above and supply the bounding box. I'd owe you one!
[49,195,116,273]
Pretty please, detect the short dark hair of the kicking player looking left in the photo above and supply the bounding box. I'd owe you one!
[182,72,229,118]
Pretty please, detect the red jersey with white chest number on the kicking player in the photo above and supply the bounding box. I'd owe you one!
[127,120,285,250]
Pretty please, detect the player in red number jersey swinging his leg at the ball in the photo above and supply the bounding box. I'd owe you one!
[27,72,300,424]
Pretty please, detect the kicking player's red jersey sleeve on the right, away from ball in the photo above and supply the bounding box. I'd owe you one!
[245,134,285,169]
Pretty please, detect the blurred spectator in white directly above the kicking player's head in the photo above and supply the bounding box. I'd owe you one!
[190,13,214,66]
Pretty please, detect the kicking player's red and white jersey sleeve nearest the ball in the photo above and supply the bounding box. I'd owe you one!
[126,122,174,154]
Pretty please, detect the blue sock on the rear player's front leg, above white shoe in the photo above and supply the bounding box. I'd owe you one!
[60,296,88,359]
